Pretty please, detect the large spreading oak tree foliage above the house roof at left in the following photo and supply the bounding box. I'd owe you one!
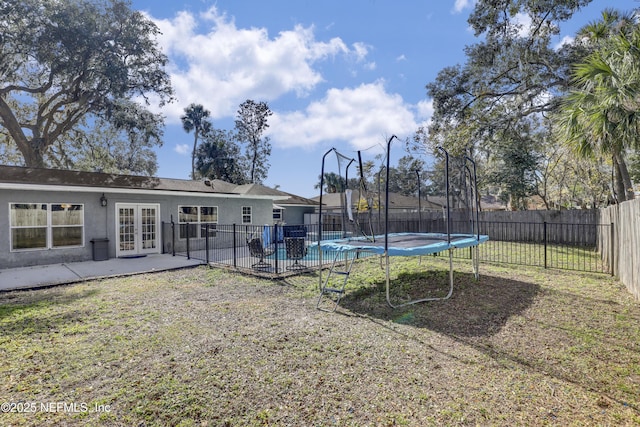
[0,0,172,171]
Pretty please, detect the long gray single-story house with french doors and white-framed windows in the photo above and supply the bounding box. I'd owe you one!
[0,166,292,269]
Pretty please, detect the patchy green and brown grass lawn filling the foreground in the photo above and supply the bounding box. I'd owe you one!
[0,257,640,426]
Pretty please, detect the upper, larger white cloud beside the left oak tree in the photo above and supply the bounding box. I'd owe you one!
[144,7,364,123]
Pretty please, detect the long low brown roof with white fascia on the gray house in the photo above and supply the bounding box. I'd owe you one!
[0,165,283,200]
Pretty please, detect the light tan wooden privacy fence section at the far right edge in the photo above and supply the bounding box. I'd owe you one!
[598,200,640,300]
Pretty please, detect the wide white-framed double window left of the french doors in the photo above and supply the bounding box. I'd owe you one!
[9,203,84,251]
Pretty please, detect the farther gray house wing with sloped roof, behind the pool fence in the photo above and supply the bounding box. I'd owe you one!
[235,184,318,225]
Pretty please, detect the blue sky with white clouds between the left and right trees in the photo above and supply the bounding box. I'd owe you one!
[132,0,624,197]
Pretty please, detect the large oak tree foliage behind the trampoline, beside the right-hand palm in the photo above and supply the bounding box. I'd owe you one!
[424,0,638,208]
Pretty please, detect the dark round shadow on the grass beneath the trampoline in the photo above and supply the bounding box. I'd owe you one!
[340,270,540,337]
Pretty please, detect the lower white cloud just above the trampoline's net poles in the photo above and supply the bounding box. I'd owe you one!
[269,81,420,149]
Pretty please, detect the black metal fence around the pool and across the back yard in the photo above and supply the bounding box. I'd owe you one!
[163,218,613,277]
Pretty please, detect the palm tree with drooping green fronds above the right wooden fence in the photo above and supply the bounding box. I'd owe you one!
[559,11,640,201]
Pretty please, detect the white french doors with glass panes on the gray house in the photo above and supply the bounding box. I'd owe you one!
[116,203,160,257]
